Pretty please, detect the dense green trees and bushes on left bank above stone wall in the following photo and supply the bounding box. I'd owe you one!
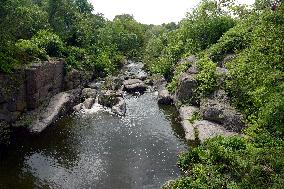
[0,0,146,74]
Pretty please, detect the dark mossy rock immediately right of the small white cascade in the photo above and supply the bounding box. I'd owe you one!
[98,90,121,108]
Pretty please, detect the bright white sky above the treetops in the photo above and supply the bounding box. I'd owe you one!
[89,0,254,25]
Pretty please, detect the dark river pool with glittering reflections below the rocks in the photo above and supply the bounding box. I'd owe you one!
[0,93,187,189]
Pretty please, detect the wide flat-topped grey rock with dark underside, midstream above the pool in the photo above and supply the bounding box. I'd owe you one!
[123,79,147,93]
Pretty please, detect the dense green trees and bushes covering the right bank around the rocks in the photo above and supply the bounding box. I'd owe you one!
[145,0,284,189]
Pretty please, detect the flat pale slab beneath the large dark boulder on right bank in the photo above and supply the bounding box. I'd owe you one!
[193,120,237,142]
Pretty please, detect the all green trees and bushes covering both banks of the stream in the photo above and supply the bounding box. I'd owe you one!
[0,0,284,189]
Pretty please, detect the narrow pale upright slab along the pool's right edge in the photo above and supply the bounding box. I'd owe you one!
[179,106,199,141]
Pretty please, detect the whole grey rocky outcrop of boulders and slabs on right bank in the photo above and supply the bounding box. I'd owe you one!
[158,56,245,142]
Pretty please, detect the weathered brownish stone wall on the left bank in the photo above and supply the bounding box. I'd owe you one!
[0,60,64,122]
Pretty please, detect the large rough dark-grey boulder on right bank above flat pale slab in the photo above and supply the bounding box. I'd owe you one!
[200,90,245,132]
